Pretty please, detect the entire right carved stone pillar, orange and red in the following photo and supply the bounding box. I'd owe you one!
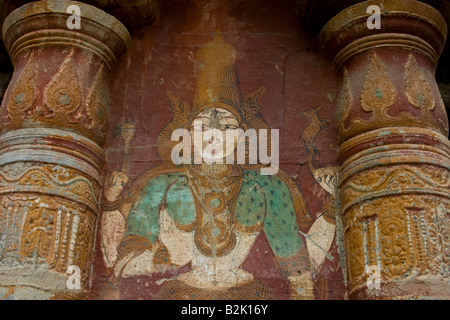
[319,0,450,299]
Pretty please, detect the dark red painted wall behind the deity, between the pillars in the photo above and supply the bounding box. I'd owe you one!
[92,0,346,299]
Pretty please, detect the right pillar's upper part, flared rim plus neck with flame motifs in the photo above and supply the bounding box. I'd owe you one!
[319,0,449,143]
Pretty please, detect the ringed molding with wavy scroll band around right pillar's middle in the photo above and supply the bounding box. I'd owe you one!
[340,128,450,212]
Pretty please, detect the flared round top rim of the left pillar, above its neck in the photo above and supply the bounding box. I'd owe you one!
[2,0,131,68]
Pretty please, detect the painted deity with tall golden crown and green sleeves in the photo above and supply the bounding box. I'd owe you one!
[101,34,336,300]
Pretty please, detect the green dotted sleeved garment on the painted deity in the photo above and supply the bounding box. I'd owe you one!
[125,170,303,258]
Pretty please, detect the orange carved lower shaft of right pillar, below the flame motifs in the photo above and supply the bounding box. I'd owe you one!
[340,128,450,297]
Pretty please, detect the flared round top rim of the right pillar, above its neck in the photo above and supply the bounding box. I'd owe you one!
[319,0,447,69]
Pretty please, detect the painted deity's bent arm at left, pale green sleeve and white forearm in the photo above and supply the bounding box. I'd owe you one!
[114,174,195,277]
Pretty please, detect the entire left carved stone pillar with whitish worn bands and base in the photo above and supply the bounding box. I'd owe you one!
[0,0,131,299]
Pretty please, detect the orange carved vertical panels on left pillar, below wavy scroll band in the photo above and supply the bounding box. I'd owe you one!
[0,194,95,276]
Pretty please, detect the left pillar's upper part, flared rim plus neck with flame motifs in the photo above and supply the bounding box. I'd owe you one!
[0,1,131,145]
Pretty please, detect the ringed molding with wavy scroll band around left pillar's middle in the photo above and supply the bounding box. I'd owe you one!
[0,129,105,212]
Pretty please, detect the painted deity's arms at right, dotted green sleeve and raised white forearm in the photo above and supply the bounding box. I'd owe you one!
[258,171,335,299]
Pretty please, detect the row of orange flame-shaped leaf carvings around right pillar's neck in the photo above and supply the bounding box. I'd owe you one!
[337,53,448,142]
